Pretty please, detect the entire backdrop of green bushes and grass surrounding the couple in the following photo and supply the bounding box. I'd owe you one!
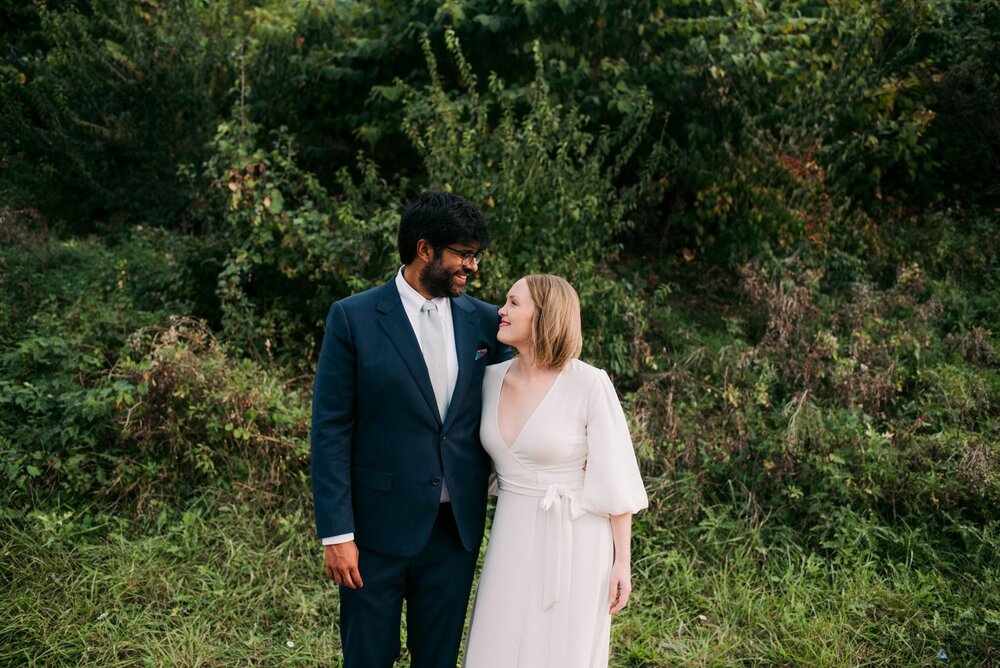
[0,0,1000,666]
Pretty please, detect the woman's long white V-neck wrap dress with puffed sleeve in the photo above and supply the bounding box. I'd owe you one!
[464,359,647,668]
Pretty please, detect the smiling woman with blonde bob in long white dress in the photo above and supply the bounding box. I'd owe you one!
[464,275,647,668]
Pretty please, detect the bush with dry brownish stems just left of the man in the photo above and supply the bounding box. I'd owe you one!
[111,319,309,495]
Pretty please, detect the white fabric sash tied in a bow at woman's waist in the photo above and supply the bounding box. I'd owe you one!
[499,476,586,610]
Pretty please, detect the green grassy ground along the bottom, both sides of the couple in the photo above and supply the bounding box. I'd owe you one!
[0,489,1000,667]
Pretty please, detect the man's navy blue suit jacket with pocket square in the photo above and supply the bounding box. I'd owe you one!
[311,280,511,557]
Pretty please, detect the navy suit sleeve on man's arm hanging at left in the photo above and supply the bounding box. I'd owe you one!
[310,303,357,538]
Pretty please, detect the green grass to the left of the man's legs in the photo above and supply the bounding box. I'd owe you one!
[0,498,338,666]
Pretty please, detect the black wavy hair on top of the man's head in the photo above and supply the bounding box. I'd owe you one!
[399,190,490,264]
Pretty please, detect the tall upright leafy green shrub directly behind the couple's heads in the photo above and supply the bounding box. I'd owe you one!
[397,32,651,373]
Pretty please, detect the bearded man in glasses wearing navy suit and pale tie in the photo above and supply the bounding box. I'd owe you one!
[312,192,511,668]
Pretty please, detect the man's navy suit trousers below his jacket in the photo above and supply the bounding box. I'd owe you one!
[340,503,478,668]
